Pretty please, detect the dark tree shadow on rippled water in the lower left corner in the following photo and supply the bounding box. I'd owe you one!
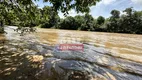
[0,40,41,80]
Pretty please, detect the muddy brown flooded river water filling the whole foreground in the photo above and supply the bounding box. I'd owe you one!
[0,26,142,80]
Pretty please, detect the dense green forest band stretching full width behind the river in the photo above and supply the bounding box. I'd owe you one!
[0,1,142,34]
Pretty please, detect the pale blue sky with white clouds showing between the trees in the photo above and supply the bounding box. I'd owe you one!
[34,0,142,18]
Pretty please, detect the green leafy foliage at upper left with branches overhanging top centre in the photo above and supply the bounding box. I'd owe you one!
[0,0,100,33]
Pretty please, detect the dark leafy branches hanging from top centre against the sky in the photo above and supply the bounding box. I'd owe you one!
[44,0,100,13]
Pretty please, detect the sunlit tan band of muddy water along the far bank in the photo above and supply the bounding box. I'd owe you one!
[37,29,142,62]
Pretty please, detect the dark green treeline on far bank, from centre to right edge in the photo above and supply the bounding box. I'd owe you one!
[50,8,142,34]
